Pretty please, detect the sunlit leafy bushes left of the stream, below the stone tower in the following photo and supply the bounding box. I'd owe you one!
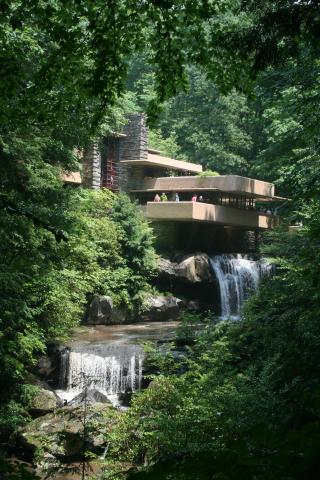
[0,188,155,442]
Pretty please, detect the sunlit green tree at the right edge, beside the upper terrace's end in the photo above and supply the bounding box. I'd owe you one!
[252,47,320,203]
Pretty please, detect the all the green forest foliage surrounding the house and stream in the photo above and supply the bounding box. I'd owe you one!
[0,0,320,480]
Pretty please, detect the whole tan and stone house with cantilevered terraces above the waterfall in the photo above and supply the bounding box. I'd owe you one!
[64,114,282,251]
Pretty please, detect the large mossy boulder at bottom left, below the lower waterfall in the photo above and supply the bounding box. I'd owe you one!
[19,403,114,463]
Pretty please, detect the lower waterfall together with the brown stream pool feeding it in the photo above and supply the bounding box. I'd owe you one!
[56,321,179,406]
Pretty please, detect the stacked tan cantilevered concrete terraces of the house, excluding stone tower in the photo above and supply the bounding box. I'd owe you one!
[121,154,280,230]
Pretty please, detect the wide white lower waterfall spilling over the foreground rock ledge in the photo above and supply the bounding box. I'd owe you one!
[57,344,143,402]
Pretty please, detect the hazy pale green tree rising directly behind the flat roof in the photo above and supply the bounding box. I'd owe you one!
[160,68,252,175]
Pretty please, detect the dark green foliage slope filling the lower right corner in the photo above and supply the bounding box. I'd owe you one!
[102,211,320,480]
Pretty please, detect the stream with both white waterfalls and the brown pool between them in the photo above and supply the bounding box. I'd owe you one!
[56,254,272,406]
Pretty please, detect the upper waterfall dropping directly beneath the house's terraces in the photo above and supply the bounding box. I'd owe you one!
[210,255,272,320]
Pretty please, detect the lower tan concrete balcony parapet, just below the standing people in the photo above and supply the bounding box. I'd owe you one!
[143,202,277,230]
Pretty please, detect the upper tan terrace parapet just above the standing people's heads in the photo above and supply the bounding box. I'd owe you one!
[131,175,278,201]
